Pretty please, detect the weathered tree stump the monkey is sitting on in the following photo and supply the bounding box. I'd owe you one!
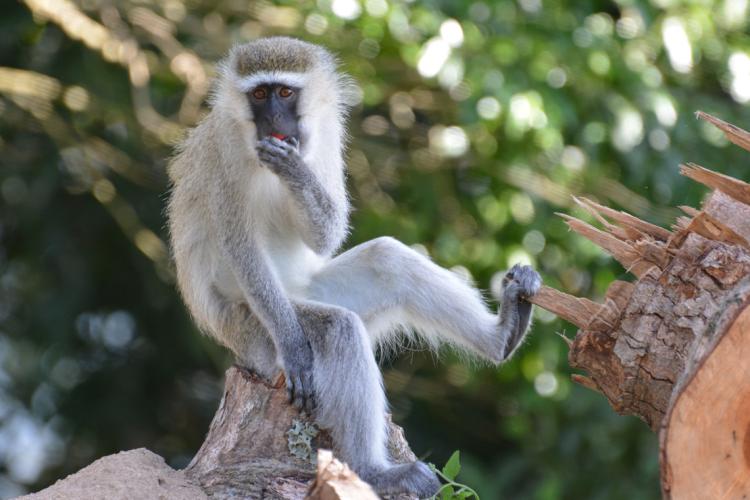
[185,366,416,500]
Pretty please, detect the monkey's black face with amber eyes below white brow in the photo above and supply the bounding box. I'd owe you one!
[247,83,299,141]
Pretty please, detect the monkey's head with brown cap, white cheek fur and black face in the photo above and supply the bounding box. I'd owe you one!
[214,37,356,148]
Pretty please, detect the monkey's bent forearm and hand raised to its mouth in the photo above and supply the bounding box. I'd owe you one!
[258,137,348,254]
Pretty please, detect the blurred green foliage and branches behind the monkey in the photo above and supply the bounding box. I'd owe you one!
[0,0,750,499]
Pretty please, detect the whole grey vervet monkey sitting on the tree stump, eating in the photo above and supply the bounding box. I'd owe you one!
[168,37,541,497]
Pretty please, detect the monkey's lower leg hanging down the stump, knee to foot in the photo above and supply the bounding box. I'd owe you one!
[295,302,440,498]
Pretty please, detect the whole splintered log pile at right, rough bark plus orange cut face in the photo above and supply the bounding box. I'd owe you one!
[532,113,750,499]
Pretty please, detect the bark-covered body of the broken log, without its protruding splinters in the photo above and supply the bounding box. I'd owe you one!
[568,213,750,430]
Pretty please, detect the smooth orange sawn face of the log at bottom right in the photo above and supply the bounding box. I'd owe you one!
[660,280,750,500]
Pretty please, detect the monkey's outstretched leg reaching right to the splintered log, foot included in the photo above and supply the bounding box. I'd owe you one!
[309,237,540,363]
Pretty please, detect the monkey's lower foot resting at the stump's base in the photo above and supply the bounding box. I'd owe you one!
[360,461,440,498]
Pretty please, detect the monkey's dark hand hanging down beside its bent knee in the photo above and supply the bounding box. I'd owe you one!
[281,338,315,415]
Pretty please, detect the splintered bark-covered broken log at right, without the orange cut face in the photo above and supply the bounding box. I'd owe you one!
[532,162,750,430]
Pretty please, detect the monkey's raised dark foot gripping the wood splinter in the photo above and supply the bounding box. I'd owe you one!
[501,264,542,359]
